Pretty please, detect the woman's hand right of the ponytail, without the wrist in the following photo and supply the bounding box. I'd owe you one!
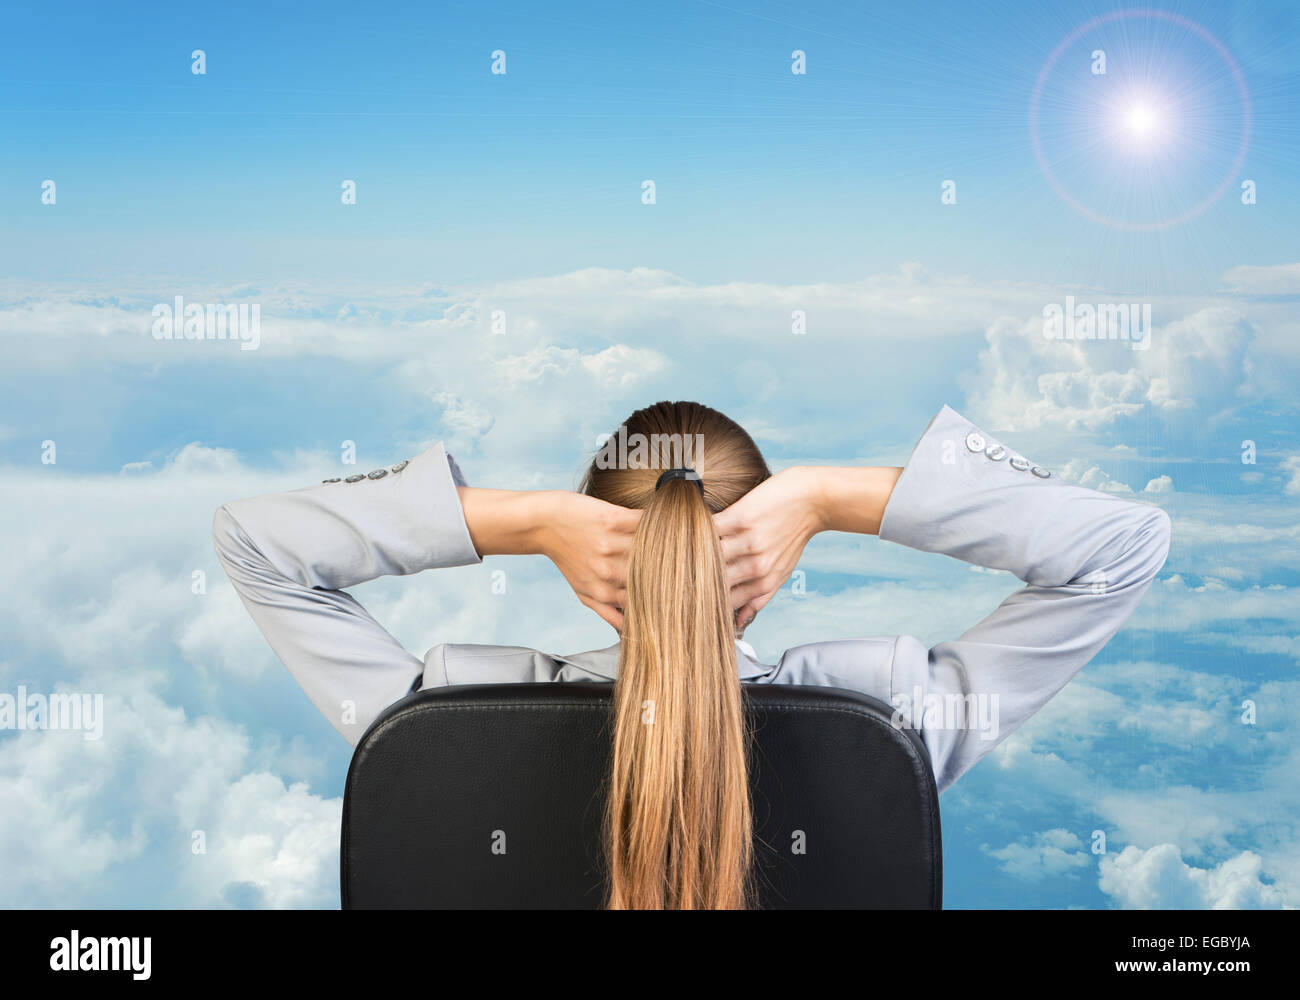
[714,466,827,629]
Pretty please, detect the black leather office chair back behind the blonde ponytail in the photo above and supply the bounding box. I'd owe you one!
[341,683,943,909]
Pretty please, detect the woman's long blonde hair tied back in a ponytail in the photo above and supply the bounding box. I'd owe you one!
[581,402,771,909]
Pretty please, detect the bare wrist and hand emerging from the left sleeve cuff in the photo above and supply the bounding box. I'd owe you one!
[458,486,641,632]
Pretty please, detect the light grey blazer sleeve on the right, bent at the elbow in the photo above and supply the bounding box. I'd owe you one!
[880,406,1170,791]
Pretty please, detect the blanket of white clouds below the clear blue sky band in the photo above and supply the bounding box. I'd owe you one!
[0,265,1300,906]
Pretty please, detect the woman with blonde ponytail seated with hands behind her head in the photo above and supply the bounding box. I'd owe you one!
[213,403,1170,909]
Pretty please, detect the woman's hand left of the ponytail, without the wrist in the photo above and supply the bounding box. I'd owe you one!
[537,492,641,633]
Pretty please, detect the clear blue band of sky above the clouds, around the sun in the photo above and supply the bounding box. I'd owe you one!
[0,3,1297,289]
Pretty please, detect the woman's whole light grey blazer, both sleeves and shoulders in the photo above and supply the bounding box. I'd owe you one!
[212,406,1170,791]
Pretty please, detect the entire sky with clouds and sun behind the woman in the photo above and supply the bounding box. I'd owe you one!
[0,0,1300,908]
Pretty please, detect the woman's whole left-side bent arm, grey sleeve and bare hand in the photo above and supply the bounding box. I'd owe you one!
[212,445,640,746]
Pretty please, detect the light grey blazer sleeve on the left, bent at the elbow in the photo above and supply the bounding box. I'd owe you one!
[212,445,481,746]
